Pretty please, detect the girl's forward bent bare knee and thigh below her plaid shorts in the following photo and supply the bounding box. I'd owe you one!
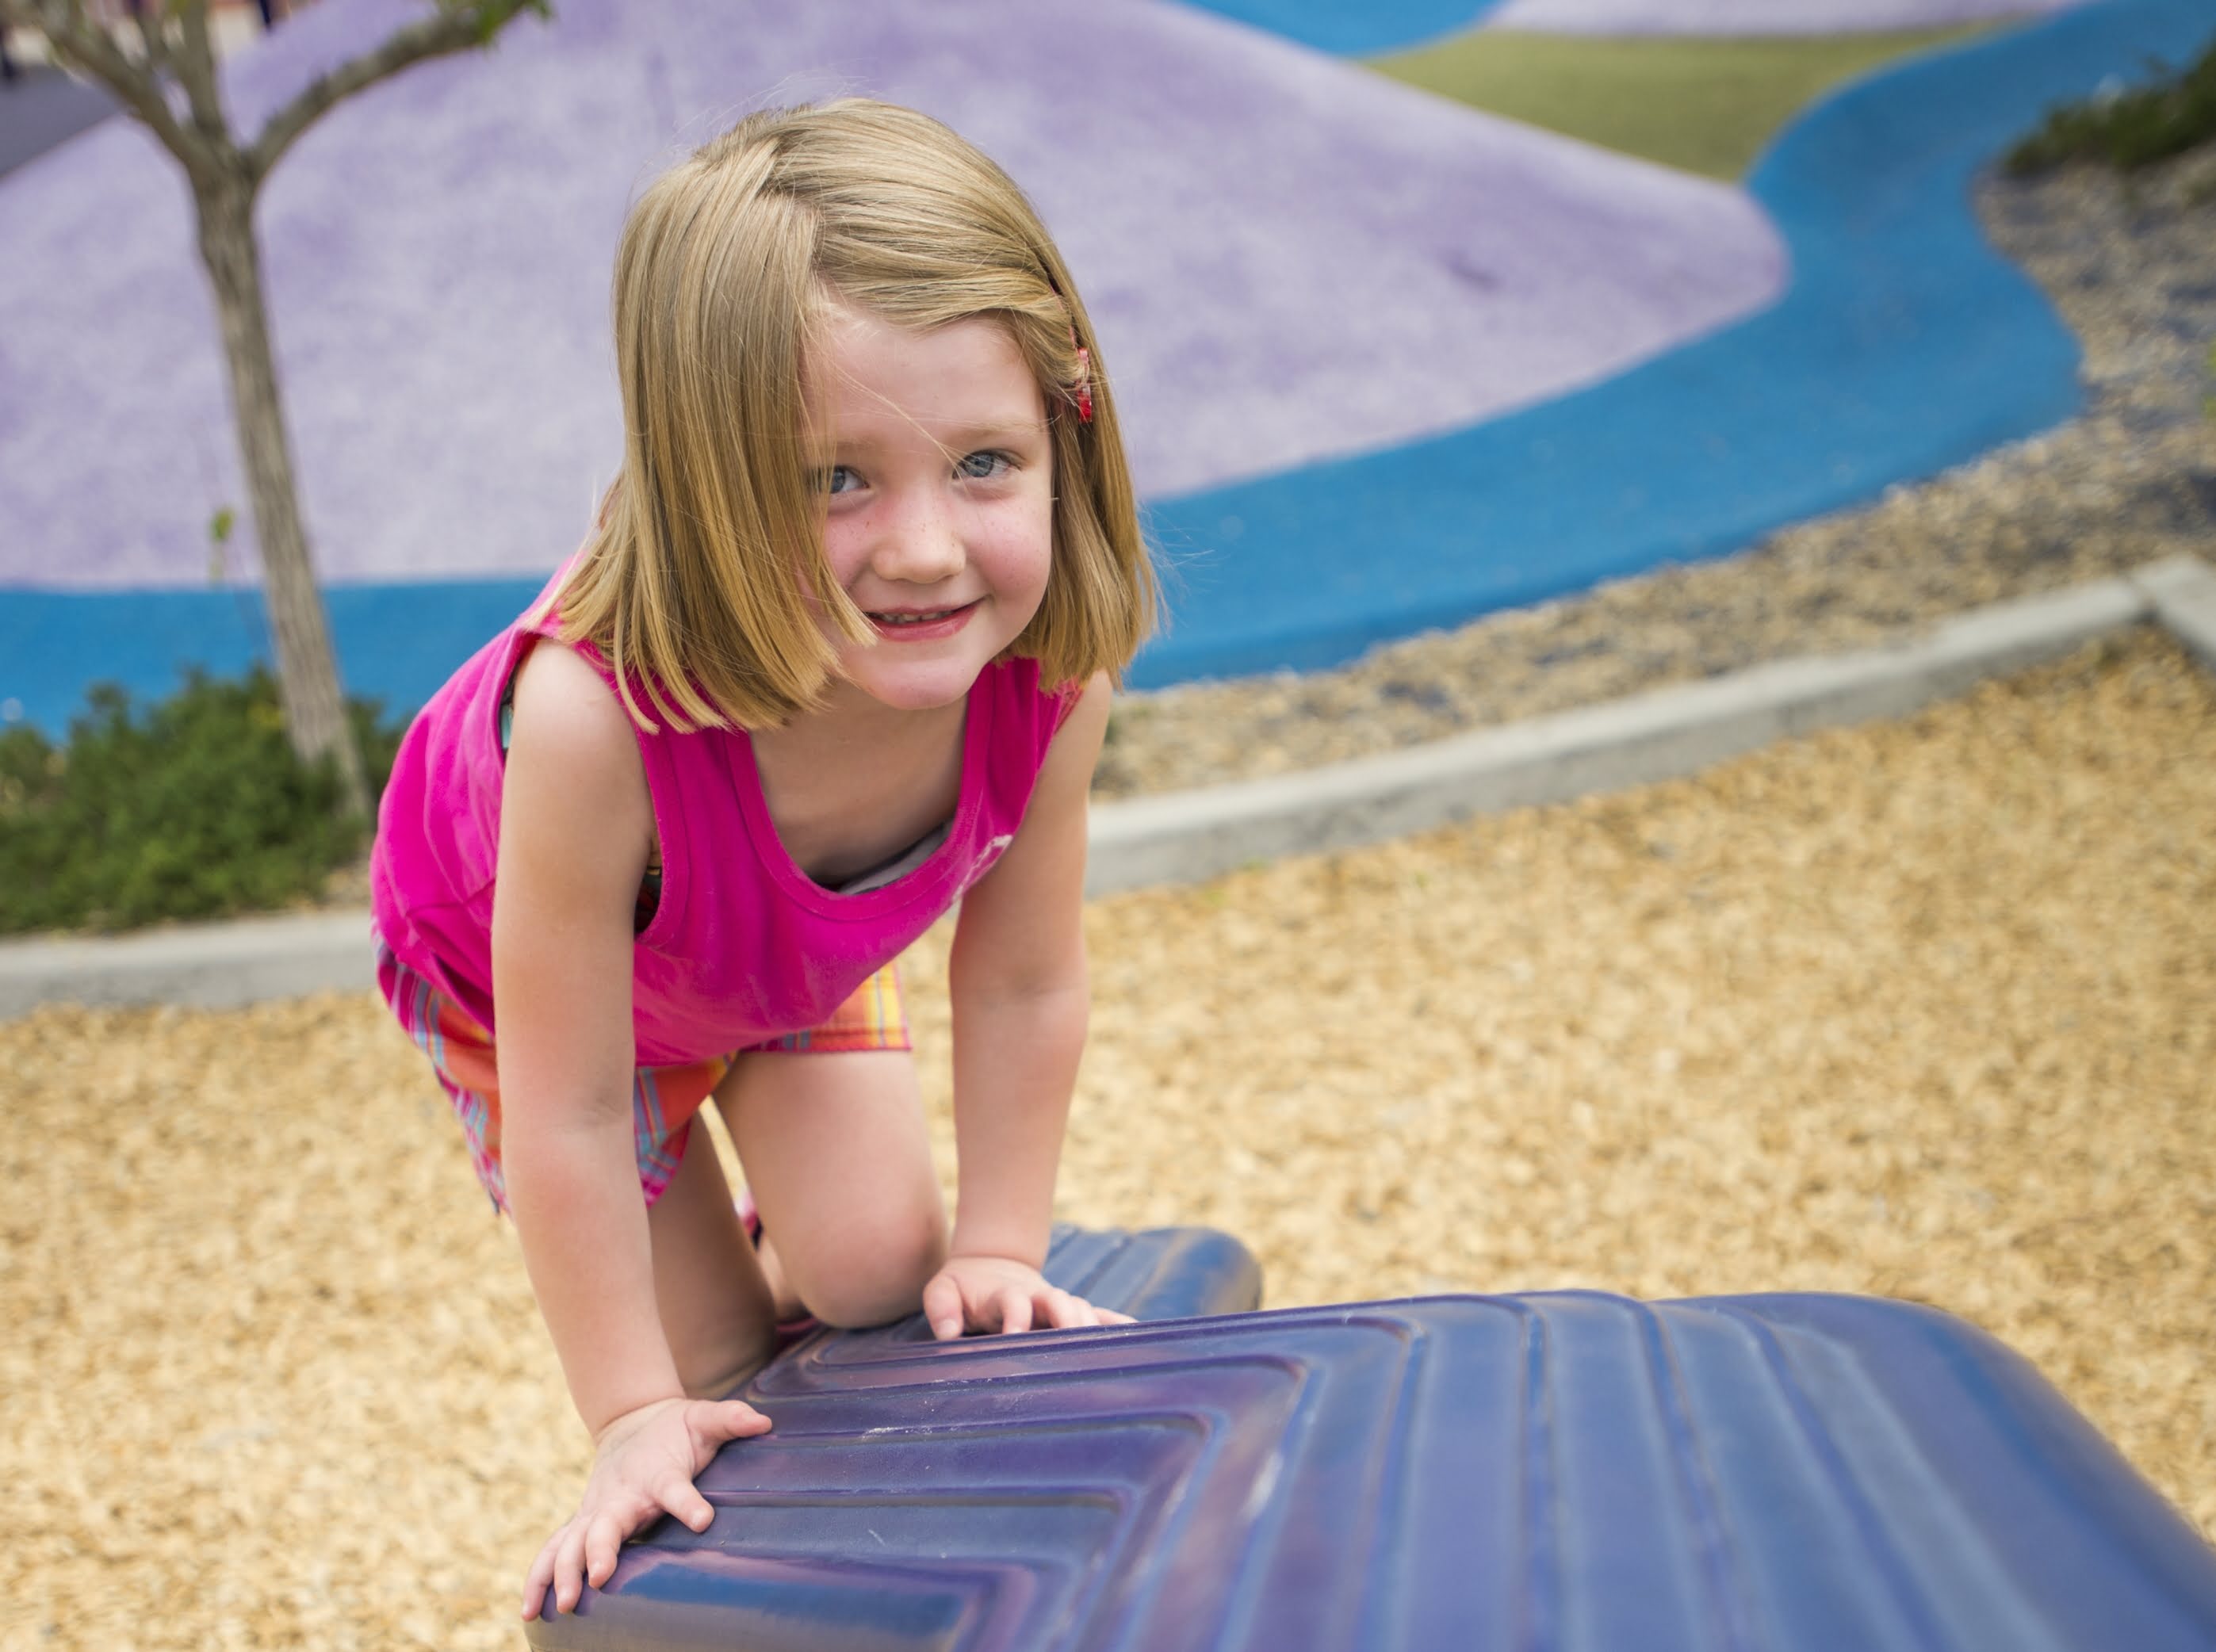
[718,1050,946,1326]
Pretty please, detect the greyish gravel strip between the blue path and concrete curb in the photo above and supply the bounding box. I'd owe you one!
[1095,148,2216,797]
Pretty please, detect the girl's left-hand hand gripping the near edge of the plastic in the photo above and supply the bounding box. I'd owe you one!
[523,1400,769,1619]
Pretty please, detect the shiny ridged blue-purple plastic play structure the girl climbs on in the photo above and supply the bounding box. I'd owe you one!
[530,1231,2216,1652]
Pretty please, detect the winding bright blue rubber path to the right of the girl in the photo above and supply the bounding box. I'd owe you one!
[1135,0,2216,686]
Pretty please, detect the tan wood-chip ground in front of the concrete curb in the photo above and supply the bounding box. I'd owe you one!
[0,631,2216,1652]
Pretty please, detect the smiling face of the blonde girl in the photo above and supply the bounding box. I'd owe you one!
[802,304,1054,711]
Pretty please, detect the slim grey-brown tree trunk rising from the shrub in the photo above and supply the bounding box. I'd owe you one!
[193,175,370,817]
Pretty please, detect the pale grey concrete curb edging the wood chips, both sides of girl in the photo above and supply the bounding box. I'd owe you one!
[0,556,2216,1016]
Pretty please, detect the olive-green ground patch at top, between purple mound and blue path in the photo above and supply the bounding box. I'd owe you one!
[1369,25,1992,179]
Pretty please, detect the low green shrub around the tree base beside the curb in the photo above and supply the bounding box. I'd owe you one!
[0,667,401,935]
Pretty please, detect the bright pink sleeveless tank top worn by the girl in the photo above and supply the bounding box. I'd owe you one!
[370,579,1075,1067]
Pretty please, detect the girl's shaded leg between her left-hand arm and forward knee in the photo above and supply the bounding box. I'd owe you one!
[647,1127,775,1400]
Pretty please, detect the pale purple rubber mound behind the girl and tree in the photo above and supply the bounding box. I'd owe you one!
[0,0,1784,589]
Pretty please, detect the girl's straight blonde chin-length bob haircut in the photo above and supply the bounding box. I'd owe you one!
[554,98,1157,733]
